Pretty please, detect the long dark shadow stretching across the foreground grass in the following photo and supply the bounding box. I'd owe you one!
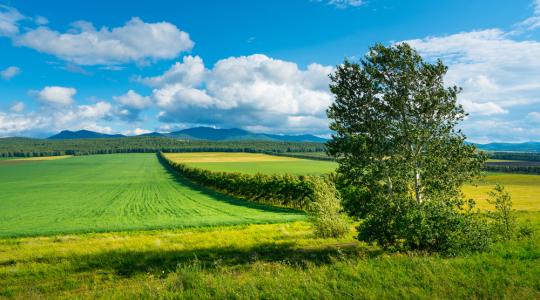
[69,243,381,277]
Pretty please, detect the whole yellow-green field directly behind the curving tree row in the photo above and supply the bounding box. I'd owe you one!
[165,152,337,175]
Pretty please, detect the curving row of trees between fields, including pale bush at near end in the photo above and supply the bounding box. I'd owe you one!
[158,152,350,237]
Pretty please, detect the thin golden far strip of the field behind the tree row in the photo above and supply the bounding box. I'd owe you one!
[165,152,299,163]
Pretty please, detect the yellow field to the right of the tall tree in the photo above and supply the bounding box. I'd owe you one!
[463,173,540,211]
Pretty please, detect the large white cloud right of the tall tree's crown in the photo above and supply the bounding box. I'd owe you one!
[407,29,540,116]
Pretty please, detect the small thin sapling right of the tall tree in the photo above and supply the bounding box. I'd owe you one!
[488,184,516,240]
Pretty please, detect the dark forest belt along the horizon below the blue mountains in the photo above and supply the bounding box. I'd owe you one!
[0,136,540,174]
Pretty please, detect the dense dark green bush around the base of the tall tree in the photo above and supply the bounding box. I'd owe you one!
[358,197,492,254]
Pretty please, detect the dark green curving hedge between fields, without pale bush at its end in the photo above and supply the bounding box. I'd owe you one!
[158,152,330,210]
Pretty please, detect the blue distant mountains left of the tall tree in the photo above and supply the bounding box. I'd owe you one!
[47,127,326,143]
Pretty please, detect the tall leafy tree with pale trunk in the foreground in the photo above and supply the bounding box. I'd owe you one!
[327,43,485,251]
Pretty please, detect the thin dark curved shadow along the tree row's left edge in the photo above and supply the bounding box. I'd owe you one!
[157,154,305,215]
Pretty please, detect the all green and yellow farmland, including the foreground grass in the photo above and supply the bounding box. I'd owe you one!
[0,153,540,299]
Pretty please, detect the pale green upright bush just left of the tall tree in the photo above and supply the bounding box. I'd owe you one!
[309,178,350,238]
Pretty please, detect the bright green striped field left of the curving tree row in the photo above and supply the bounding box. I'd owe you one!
[0,154,303,236]
